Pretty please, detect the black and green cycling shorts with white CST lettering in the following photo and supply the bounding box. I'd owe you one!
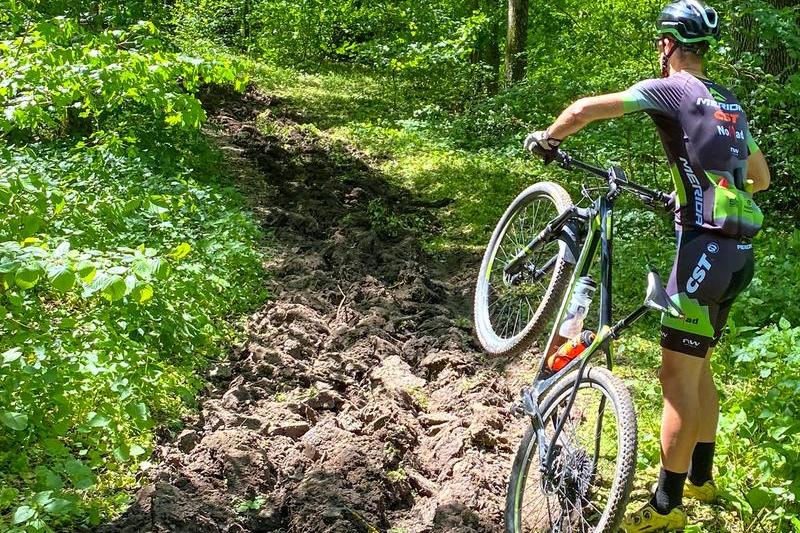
[661,231,753,357]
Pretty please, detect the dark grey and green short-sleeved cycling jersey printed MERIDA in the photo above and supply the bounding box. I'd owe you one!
[623,72,763,237]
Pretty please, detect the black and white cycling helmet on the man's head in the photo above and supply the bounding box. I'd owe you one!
[656,0,719,45]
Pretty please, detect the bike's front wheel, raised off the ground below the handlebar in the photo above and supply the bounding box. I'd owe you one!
[475,182,572,356]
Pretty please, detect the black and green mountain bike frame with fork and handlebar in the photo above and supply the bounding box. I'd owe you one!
[509,152,668,474]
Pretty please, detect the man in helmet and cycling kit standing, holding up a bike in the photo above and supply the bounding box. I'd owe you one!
[525,0,770,533]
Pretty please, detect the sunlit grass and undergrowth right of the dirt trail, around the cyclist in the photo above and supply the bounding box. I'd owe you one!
[249,63,800,533]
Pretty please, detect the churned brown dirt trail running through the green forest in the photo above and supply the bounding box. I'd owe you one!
[102,85,536,533]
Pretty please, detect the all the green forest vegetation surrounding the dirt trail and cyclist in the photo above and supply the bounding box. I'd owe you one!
[0,0,800,531]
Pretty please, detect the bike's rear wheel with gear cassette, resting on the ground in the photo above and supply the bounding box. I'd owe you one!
[505,367,636,533]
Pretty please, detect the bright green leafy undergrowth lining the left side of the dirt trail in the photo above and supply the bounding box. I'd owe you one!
[0,3,264,531]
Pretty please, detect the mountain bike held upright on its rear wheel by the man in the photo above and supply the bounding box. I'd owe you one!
[475,150,682,533]
